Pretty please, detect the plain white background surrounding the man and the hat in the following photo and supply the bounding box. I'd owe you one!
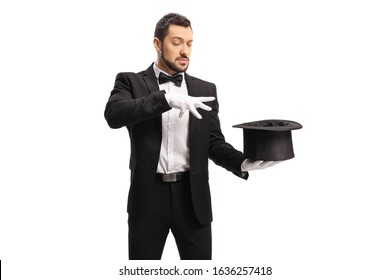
[0,0,390,280]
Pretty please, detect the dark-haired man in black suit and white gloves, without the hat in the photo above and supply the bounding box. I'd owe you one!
[105,13,273,260]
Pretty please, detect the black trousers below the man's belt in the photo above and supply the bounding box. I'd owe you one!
[129,176,211,260]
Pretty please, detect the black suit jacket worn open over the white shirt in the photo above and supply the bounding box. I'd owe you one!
[104,66,248,224]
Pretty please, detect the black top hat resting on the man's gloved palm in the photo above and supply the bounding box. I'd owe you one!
[233,120,302,161]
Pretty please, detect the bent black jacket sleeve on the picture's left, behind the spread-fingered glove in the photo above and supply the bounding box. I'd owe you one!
[104,73,171,128]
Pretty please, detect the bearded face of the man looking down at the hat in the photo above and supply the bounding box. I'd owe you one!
[153,25,193,75]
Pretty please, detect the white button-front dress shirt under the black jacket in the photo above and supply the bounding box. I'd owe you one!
[153,64,190,174]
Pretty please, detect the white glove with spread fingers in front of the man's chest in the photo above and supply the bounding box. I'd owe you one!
[165,94,215,119]
